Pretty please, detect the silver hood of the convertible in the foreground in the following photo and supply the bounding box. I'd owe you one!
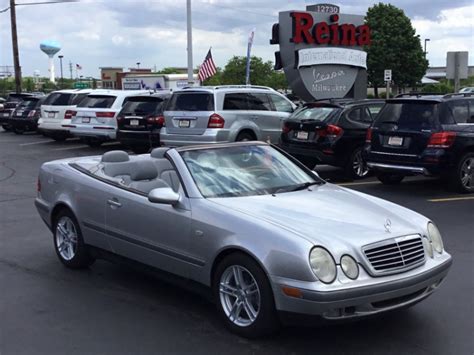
[210,183,428,253]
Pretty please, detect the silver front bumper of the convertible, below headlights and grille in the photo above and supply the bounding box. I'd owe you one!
[272,257,452,320]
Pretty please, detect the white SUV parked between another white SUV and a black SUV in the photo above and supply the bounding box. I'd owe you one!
[70,90,153,147]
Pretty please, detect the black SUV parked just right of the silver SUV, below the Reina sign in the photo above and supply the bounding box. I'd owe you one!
[280,100,385,179]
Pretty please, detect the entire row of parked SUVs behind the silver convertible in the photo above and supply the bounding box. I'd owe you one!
[0,85,474,192]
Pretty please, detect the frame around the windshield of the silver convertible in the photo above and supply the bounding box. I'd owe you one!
[178,142,326,199]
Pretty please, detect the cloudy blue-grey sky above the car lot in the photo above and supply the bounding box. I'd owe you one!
[0,0,474,77]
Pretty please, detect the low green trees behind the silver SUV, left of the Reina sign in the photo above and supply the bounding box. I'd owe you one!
[222,56,273,85]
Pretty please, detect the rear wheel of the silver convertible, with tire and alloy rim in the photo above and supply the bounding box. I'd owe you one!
[53,209,95,269]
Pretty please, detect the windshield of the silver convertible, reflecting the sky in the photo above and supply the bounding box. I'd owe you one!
[181,145,323,198]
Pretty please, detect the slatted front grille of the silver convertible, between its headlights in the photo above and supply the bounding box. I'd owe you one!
[363,235,425,274]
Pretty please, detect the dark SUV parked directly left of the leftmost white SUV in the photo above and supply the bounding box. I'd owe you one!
[10,96,47,134]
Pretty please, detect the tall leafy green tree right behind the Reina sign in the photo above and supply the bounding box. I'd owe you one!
[365,3,428,97]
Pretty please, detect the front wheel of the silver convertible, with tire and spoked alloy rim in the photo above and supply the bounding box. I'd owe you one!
[213,253,279,338]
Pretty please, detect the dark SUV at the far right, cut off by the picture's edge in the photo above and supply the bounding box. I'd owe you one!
[364,94,474,192]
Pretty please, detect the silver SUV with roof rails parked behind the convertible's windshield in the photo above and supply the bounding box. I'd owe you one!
[160,85,296,146]
